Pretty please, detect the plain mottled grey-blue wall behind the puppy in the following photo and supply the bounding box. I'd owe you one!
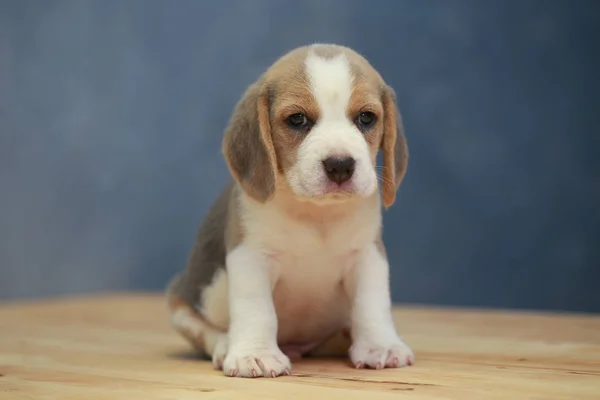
[0,0,600,311]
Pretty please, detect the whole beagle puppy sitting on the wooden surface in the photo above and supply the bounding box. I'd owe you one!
[167,44,414,377]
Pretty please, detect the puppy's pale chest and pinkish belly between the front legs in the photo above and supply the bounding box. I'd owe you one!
[240,195,380,342]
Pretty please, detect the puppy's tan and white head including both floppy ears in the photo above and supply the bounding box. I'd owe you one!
[223,45,408,208]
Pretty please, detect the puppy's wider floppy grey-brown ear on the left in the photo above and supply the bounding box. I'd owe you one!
[222,82,277,202]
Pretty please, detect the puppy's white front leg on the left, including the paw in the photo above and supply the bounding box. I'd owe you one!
[223,244,291,378]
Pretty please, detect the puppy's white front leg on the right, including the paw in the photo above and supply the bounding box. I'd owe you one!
[347,243,414,369]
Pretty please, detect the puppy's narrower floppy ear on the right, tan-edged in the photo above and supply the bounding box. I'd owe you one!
[381,85,408,208]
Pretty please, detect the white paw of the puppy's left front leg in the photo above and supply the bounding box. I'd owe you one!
[223,348,292,378]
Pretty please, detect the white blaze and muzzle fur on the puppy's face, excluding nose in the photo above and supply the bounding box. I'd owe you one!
[286,50,377,197]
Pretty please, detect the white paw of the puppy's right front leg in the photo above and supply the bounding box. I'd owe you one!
[350,340,415,369]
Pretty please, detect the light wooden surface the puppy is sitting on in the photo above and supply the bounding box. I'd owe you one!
[0,295,600,400]
